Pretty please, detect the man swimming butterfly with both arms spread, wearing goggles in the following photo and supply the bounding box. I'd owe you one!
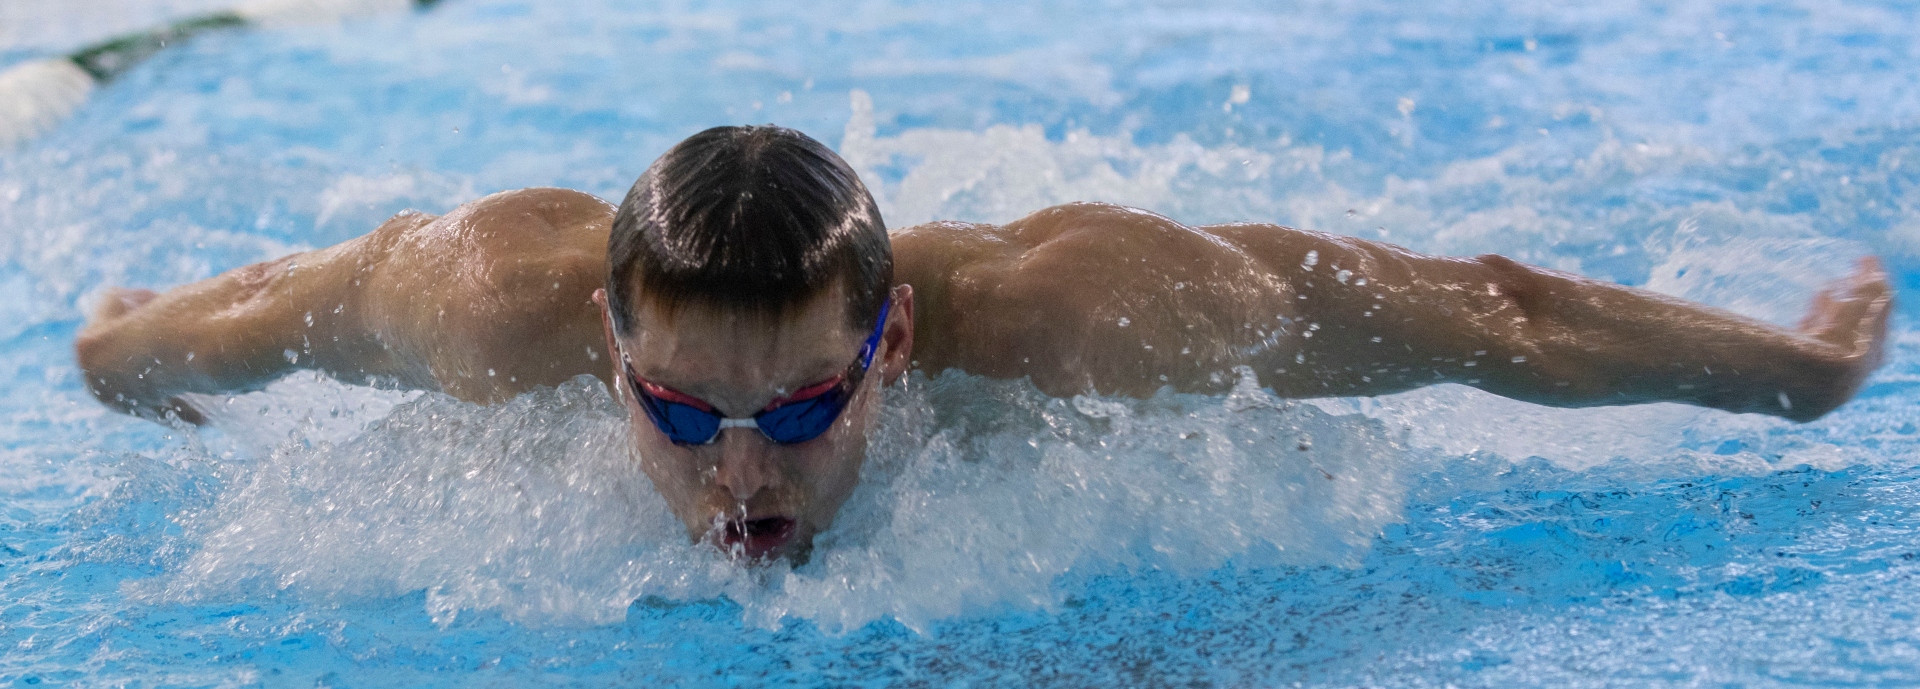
[75,127,1891,558]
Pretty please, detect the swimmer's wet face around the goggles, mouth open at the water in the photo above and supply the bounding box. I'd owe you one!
[593,286,914,560]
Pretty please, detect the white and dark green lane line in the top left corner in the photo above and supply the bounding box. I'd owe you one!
[0,0,440,150]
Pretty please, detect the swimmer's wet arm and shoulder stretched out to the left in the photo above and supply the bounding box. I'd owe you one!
[75,188,612,422]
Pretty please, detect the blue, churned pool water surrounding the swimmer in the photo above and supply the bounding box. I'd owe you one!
[0,0,1920,687]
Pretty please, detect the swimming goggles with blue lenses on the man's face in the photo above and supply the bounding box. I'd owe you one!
[620,299,893,445]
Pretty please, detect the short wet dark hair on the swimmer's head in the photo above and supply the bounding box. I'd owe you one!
[607,125,893,334]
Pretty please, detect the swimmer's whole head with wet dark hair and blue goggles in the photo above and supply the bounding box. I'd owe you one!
[595,127,912,558]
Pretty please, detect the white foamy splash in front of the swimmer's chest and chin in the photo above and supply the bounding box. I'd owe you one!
[120,374,1405,630]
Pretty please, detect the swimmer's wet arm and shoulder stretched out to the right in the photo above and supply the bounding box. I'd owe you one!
[895,203,1891,420]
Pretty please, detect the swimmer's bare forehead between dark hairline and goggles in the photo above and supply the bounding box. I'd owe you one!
[620,286,860,403]
